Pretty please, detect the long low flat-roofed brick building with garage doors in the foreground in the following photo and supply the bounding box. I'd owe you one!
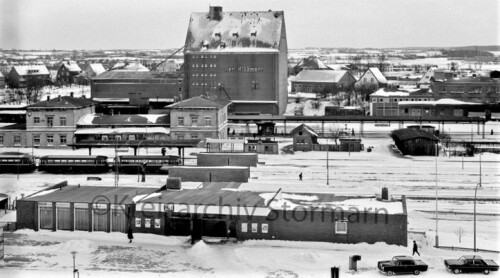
[17,182,408,246]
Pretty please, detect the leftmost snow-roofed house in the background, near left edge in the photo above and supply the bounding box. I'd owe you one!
[9,65,50,88]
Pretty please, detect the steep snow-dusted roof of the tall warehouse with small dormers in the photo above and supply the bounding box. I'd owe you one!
[185,8,284,52]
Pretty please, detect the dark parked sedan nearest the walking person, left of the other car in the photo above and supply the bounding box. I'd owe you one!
[377,256,428,275]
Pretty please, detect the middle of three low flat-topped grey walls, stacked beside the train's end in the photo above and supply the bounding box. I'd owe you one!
[196,153,259,167]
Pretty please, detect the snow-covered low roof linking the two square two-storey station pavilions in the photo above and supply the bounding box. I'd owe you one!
[77,114,170,125]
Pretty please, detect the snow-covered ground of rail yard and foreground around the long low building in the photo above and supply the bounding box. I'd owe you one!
[0,125,500,278]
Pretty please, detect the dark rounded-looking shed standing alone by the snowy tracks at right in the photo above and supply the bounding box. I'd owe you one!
[391,128,439,156]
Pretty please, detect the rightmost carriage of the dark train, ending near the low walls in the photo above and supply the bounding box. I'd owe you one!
[113,155,182,174]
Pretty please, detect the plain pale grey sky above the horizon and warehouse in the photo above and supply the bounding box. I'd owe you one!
[0,0,500,50]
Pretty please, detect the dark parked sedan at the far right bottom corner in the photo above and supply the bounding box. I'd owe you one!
[444,255,498,274]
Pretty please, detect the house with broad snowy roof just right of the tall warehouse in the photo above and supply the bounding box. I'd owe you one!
[291,70,356,93]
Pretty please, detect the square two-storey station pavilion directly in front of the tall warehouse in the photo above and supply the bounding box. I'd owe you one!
[167,97,230,140]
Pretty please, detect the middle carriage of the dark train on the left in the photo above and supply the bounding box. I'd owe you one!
[38,155,109,173]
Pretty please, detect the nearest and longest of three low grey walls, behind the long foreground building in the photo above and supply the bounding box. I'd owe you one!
[168,166,250,182]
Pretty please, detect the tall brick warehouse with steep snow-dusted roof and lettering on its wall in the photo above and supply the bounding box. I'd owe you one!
[184,6,288,115]
